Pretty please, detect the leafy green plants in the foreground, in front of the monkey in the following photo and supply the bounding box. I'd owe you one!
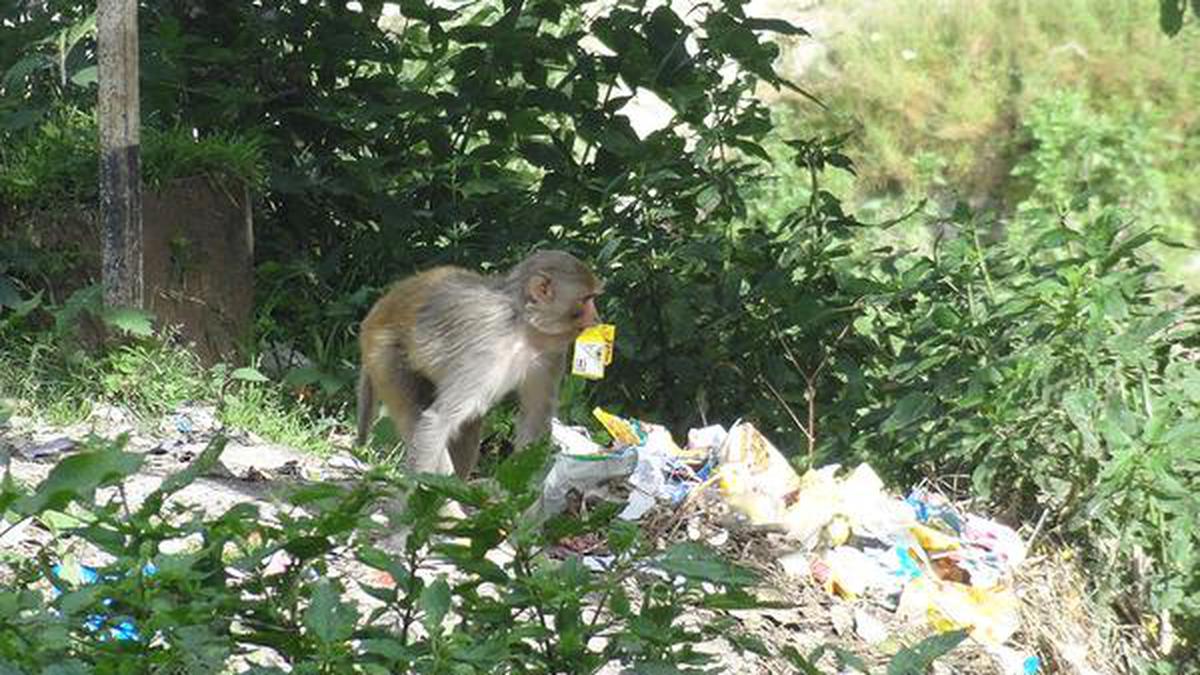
[0,427,757,674]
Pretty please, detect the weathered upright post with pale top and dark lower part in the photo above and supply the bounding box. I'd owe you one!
[96,0,144,307]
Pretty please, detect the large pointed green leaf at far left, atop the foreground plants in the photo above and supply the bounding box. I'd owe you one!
[13,446,145,515]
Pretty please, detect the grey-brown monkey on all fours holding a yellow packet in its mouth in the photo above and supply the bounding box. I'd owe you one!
[358,251,601,478]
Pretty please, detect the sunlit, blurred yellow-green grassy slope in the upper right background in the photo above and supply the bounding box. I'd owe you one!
[777,0,1200,283]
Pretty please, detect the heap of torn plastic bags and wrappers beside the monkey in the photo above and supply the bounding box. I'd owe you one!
[540,408,1038,674]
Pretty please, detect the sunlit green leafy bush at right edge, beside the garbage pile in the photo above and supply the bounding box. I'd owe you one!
[834,200,1200,653]
